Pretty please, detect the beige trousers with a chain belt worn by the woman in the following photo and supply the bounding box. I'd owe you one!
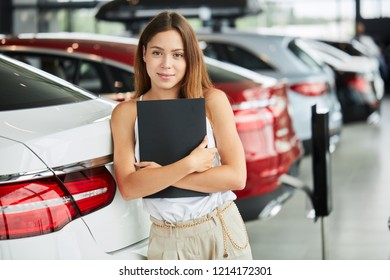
[148,201,252,260]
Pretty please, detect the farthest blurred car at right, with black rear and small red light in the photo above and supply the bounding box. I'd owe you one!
[305,39,385,123]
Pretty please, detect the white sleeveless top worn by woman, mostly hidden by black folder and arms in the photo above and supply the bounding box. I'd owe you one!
[134,96,236,223]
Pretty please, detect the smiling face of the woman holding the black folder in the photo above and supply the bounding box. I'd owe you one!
[144,30,187,94]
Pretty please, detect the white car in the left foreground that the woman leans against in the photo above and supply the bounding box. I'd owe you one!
[0,55,150,260]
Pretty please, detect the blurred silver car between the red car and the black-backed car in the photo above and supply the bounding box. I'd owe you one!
[198,30,343,154]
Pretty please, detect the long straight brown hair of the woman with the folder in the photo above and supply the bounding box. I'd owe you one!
[134,11,213,98]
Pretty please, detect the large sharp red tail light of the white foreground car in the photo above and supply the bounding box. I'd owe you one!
[0,167,116,240]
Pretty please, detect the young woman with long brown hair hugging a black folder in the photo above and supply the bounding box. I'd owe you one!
[111,12,252,259]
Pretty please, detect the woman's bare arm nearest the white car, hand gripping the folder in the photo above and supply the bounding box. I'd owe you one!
[111,100,216,200]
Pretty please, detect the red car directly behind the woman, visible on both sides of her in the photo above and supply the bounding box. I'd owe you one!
[0,33,303,220]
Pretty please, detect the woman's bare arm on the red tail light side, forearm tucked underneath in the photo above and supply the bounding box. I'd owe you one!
[174,90,247,192]
